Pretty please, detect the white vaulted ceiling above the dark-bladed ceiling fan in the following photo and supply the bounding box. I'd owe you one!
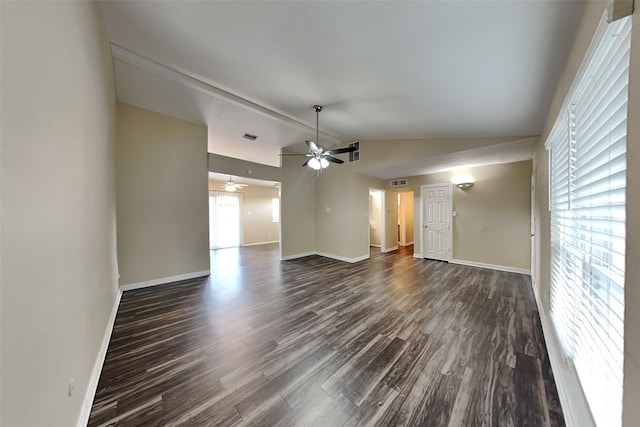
[100,0,584,177]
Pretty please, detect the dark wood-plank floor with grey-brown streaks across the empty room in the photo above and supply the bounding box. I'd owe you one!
[89,245,564,427]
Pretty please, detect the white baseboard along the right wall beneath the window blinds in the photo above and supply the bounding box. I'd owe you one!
[533,286,595,427]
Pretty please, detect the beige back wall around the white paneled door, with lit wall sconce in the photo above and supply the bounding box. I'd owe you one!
[409,160,532,270]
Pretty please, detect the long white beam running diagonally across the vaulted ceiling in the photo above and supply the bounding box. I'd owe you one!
[111,43,341,146]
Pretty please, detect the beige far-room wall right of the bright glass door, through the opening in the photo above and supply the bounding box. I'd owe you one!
[209,179,280,245]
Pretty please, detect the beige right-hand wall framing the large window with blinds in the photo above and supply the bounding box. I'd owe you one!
[534,1,640,427]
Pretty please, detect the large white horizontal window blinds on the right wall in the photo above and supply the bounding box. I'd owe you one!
[547,13,631,426]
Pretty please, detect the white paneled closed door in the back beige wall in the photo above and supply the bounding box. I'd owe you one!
[421,185,451,261]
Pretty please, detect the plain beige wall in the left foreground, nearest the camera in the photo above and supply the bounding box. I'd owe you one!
[0,2,117,427]
